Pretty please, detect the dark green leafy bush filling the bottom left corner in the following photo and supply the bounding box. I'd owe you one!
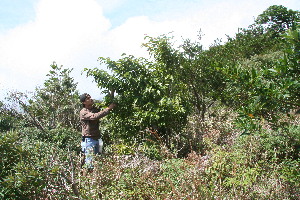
[0,132,44,199]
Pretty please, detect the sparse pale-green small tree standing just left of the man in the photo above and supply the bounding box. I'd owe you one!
[6,63,80,132]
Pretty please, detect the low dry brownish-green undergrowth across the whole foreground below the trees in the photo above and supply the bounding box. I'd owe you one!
[0,121,300,199]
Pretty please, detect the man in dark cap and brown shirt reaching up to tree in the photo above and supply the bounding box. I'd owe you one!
[80,93,116,168]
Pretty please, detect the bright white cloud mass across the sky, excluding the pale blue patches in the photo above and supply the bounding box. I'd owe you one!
[0,0,296,97]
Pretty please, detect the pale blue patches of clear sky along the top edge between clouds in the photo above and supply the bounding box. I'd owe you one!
[0,0,205,31]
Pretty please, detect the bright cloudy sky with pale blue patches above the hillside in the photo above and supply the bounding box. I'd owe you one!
[0,0,300,100]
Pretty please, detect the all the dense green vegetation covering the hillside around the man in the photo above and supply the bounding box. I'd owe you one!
[0,6,300,199]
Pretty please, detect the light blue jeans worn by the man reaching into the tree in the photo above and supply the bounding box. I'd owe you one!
[81,138,102,168]
